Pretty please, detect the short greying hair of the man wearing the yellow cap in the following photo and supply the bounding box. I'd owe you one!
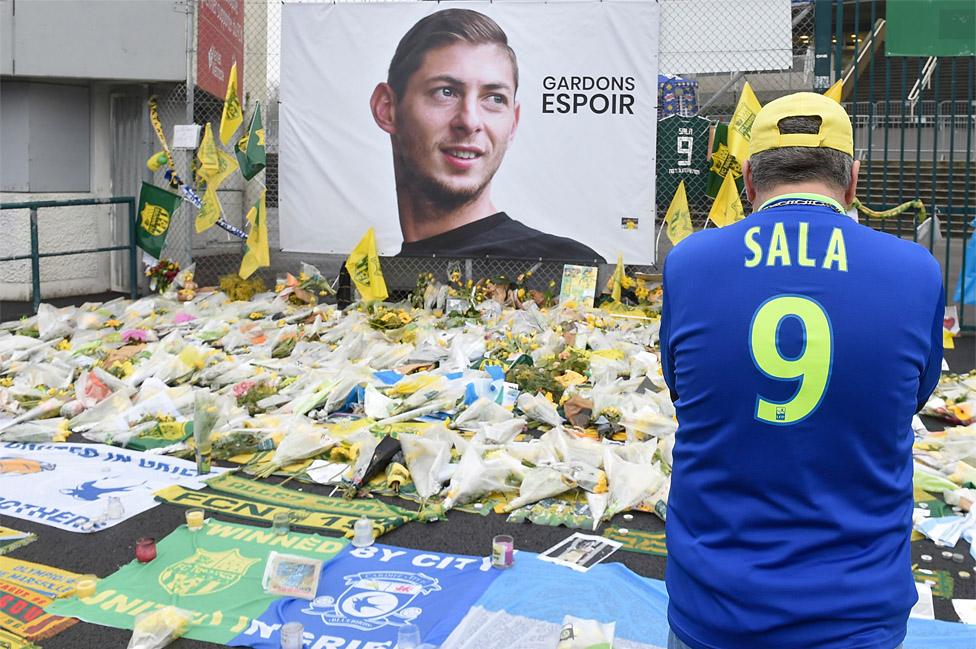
[749,116,854,193]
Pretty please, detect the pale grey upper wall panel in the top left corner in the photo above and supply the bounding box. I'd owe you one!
[0,0,186,81]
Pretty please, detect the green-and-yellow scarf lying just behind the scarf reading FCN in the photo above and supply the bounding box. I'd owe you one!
[207,473,417,534]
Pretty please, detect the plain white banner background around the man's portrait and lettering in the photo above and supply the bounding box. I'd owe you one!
[279,1,658,263]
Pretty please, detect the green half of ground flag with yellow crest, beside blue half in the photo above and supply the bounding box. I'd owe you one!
[50,520,348,644]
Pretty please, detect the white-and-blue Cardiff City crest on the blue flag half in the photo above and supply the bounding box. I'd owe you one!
[302,570,441,631]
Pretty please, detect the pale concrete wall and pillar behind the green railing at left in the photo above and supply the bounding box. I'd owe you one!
[0,81,112,300]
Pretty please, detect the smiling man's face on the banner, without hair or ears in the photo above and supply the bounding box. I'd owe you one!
[393,43,519,204]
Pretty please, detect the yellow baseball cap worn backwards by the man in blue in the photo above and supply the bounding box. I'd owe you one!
[749,92,854,157]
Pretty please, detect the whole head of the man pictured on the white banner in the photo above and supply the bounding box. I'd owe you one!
[370,9,519,208]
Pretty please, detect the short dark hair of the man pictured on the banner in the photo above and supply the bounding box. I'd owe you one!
[386,9,518,101]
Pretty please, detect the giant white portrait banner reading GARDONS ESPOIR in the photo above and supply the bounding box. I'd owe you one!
[279,1,659,263]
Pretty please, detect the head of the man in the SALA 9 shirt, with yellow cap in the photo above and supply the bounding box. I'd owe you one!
[743,92,860,205]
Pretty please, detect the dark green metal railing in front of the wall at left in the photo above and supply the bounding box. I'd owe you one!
[0,196,139,313]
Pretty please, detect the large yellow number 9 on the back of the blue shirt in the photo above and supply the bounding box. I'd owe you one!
[749,295,834,426]
